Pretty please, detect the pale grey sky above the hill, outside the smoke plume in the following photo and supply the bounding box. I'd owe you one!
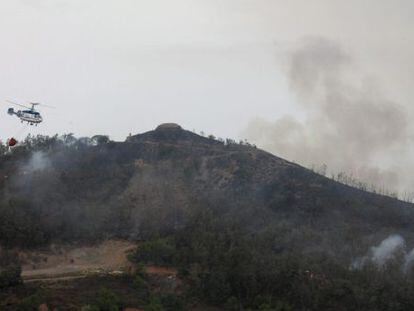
[0,0,414,180]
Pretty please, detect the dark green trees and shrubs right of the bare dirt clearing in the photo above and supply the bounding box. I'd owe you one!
[129,213,414,310]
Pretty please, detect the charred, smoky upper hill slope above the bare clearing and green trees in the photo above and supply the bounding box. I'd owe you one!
[0,126,414,254]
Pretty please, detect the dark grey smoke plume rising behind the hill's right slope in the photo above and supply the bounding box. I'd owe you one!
[245,38,410,195]
